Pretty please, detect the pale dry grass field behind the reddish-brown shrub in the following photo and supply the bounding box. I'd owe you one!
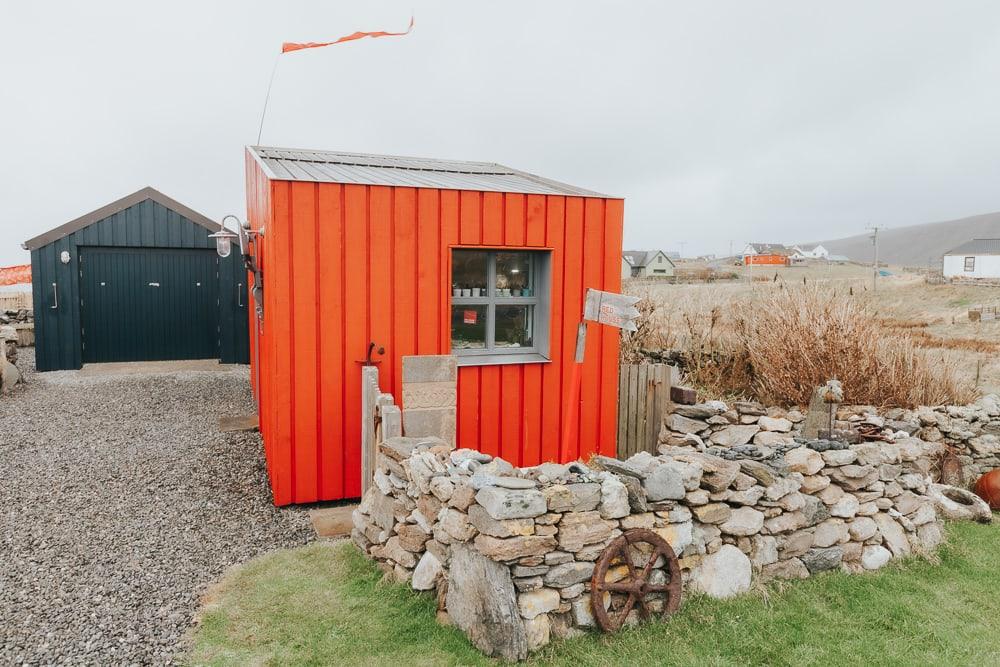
[625,264,1000,400]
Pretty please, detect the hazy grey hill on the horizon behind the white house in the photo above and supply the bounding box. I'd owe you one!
[819,212,1000,267]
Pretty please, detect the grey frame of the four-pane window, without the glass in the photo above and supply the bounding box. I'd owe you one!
[448,246,552,366]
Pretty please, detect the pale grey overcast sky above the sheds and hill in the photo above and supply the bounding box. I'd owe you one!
[0,0,1000,266]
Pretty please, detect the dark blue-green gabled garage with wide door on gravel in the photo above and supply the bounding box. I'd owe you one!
[24,188,249,371]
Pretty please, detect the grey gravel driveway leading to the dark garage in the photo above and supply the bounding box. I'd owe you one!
[0,349,312,665]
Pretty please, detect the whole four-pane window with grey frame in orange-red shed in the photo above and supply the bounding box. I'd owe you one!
[451,248,550,364]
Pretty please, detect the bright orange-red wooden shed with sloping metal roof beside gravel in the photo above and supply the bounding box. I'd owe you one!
[246,146,624,505]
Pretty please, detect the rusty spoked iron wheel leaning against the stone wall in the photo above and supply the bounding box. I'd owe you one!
[590,528,681,632]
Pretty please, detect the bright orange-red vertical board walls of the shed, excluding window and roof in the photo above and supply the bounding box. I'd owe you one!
[248,161,623,505]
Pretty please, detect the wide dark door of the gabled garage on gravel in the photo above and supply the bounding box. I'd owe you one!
[80,248,219,363]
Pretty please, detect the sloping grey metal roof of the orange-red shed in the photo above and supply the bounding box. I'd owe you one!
[247,146,608,197]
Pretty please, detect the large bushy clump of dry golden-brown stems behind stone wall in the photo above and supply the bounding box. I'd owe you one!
[647,285,975,407]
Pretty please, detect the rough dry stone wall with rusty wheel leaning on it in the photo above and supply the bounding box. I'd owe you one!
[352,401,976,659]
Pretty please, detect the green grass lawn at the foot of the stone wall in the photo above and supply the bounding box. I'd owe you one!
[187,524,1000,667]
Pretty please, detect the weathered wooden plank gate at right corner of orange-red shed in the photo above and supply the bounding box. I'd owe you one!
[618,364,670,459]
